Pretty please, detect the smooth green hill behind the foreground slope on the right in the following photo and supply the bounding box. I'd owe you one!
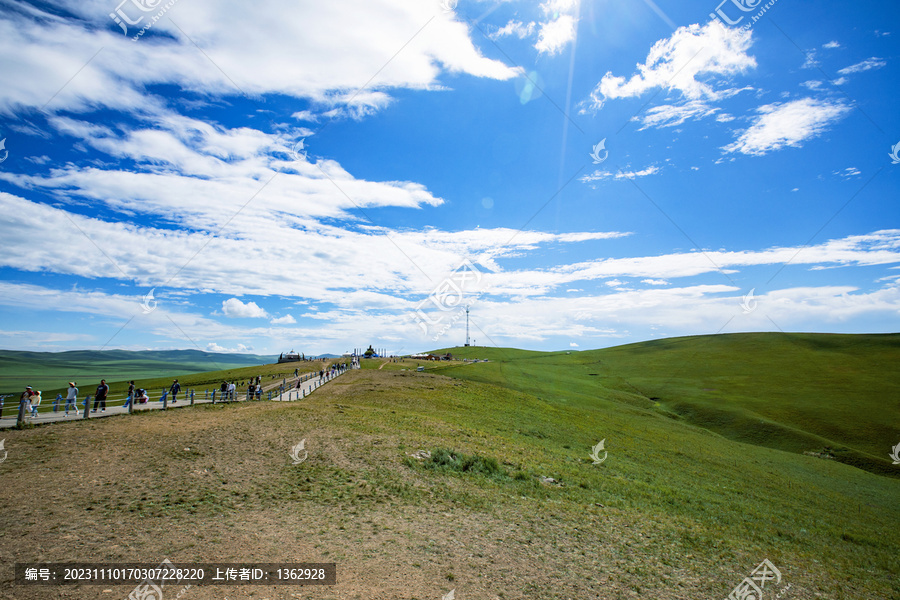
[429,333,900,475]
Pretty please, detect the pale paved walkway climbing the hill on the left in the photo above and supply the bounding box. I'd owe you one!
[0,368,350,429]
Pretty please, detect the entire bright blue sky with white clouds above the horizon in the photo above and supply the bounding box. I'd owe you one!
[0,0,900,354]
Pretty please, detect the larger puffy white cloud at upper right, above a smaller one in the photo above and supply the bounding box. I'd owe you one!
[591,21,756,108]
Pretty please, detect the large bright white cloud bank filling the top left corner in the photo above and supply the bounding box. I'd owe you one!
[0,0,519,114]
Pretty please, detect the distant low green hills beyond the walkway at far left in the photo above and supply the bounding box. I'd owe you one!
[0,350,277,393]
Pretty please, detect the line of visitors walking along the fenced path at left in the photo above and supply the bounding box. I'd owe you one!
[0,361,358,418]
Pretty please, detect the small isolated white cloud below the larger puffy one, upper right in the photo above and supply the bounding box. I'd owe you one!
[723,98,850,156]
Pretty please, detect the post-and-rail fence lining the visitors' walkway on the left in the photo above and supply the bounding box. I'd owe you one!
[0,365,353,429]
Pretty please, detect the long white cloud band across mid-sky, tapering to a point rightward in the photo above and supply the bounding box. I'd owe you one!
[0,192,629,308]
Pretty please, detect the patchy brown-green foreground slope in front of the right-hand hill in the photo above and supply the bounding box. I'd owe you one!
[0,356,900,600]
